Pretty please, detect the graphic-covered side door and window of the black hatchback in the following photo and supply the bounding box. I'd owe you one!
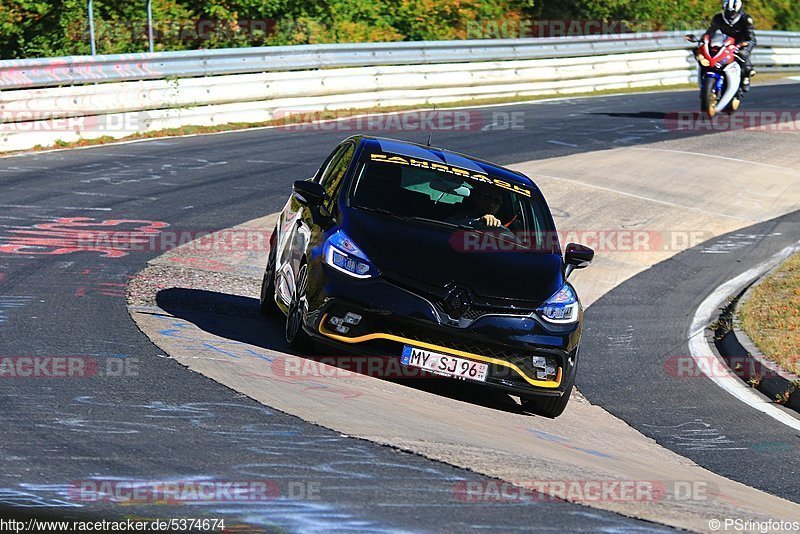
[275,141,355,305]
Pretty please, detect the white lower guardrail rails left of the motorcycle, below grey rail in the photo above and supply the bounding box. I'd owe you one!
[0,50,691,123]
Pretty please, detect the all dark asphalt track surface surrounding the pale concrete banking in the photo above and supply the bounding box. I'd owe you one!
[0,84,800,532]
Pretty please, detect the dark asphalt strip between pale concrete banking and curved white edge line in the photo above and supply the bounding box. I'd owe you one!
[578,212,800,502]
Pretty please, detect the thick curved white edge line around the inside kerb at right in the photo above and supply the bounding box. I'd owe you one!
[689,241,800,430]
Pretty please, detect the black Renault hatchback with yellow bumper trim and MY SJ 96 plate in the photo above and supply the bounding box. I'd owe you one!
[261,136,594,417]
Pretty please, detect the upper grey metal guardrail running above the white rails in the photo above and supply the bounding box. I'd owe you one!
[0,31,800,89]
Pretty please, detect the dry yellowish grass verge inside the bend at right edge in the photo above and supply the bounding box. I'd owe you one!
[739,253,800,375]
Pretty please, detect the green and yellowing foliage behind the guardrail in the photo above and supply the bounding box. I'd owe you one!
[0,0,800,59]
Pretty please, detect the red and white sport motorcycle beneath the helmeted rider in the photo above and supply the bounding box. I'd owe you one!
[686,33,742,117]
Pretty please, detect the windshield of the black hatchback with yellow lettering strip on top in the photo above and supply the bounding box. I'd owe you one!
[350,153,553,250]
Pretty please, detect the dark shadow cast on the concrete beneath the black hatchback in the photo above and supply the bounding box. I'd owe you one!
[156,288,527,414]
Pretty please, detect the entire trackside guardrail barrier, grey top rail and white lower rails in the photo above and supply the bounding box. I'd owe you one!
[0,31,800,151]
